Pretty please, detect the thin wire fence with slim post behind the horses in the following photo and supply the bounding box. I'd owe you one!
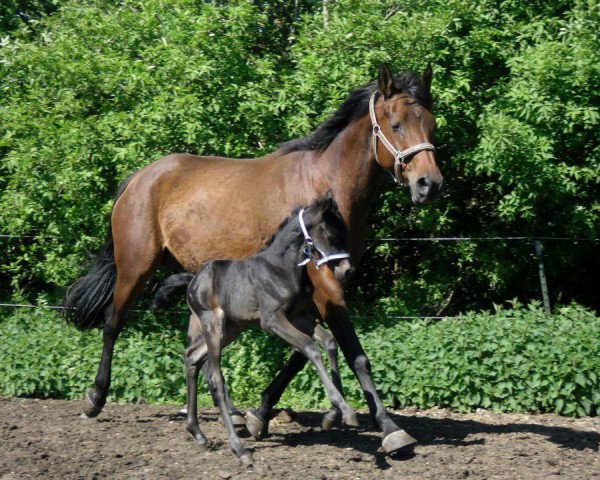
[0,234,600,320]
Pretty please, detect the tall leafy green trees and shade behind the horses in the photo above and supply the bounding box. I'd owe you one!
[0,0,600,414]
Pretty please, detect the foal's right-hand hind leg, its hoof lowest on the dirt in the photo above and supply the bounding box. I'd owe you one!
[202,308,253,466]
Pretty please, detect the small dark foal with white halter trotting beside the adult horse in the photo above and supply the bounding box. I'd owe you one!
[186,192,357,465]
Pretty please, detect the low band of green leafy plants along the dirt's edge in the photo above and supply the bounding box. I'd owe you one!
[0,304,600,416]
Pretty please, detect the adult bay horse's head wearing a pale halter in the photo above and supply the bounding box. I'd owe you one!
[374,64,443,204]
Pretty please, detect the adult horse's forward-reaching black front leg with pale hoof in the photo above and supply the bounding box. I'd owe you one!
[309,268,417,453]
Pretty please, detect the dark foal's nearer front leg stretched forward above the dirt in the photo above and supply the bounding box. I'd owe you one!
[261,312,358,426]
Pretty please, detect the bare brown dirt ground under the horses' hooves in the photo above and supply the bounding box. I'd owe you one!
[0,397,600,480]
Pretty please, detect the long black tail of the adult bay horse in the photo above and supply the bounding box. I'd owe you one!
[63,177,131,330]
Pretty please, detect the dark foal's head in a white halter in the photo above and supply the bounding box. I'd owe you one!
[302,190,353,281]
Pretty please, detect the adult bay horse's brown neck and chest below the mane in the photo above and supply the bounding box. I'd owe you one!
[310,115,385,256]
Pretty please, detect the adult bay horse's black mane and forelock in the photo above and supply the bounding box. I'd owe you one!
[279,72,433,153]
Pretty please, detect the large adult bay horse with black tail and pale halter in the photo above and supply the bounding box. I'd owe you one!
[64,64,443,452]
